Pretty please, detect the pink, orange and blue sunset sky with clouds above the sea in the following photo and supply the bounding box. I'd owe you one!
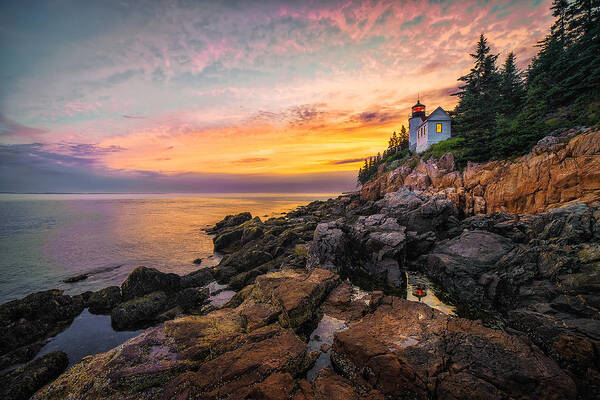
[0,0,552,192]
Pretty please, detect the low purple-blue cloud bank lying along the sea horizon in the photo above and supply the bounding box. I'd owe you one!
[0,143,356,193]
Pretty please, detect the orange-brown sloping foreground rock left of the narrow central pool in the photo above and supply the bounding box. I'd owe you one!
[33,270,339,399]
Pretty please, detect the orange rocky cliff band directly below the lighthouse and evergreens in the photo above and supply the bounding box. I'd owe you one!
[361,129,600,215]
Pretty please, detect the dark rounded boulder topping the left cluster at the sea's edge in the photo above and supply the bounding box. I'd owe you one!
[121,266,181,301]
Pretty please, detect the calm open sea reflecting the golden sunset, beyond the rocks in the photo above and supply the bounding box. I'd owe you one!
[0,194,332,303]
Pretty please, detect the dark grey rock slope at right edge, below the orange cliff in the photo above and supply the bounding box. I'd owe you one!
[421,204,600,397]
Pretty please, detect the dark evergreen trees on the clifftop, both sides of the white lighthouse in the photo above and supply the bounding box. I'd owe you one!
[358,0,600,184]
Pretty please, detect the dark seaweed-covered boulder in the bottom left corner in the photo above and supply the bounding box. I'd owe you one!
[0,351,69,400]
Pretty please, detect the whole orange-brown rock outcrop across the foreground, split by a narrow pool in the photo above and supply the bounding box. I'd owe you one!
[33,269,576,400]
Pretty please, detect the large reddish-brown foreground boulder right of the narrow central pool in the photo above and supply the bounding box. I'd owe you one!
[331,297,577,400]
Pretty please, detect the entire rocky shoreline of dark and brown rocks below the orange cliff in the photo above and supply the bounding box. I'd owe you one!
[0,137,600,399]
